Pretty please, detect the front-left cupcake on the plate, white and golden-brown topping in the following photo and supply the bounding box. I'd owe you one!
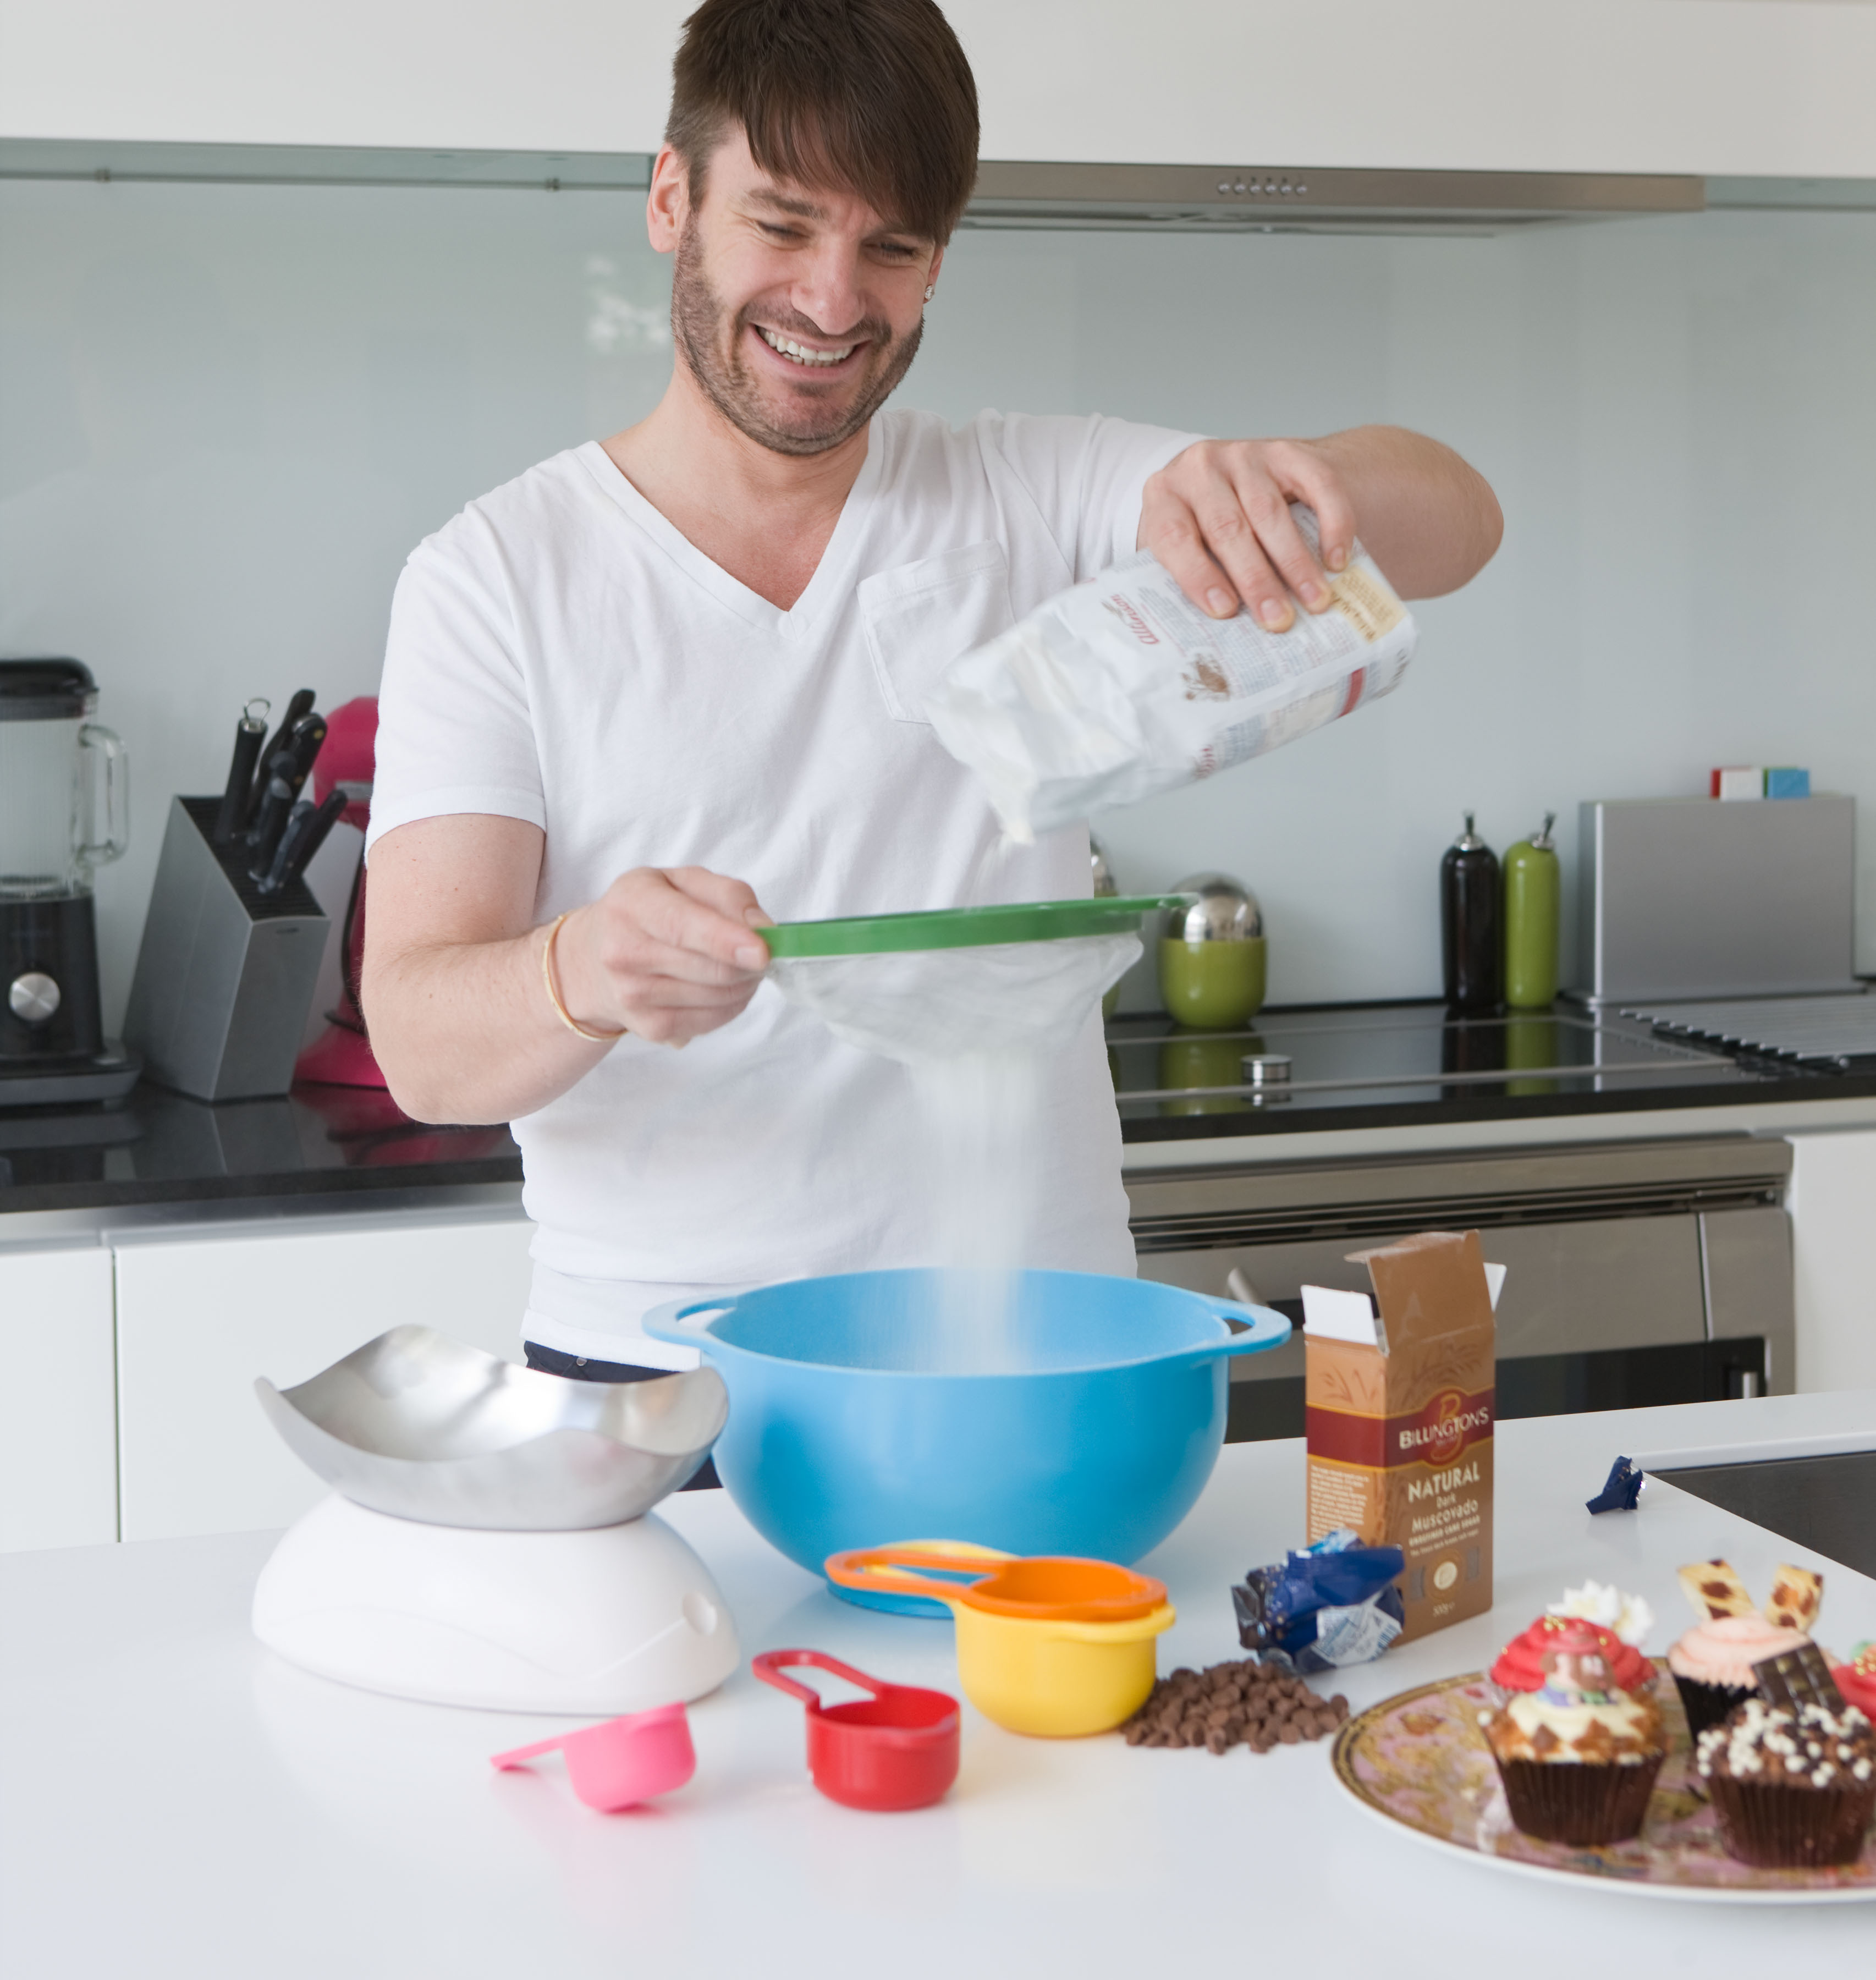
[1480,1621,1666,1849]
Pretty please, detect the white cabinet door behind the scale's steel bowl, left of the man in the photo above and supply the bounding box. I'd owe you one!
[113,1212,534,1541]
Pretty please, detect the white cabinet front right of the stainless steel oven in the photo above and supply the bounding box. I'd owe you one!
[1787,1129,1876,1390]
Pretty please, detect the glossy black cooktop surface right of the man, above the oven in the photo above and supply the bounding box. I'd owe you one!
[1108,1002,1876,1141]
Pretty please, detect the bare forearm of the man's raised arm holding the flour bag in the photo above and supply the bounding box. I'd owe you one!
[1314,426,1504,598]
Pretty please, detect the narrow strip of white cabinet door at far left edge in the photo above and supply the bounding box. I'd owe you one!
[0,1244,117,1552]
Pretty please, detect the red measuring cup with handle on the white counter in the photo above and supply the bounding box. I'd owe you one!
[752,1649,958,1812]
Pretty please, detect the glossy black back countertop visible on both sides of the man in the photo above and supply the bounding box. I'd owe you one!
[0,1002,1876,1218]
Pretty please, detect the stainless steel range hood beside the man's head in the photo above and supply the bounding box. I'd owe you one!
[964,158,1706,235]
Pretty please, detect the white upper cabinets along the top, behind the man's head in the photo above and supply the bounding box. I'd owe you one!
[0,0,1876,178]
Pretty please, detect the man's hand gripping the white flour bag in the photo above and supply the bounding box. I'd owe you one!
[1140,439,1356,631]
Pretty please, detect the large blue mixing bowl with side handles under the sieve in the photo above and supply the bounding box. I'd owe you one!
[643,1269,1290,1614]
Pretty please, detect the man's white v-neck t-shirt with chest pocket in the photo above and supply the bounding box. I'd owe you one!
[370,412,1193,1368]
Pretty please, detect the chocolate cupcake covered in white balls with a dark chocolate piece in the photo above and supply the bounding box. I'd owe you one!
[1694,1697,1876,1869]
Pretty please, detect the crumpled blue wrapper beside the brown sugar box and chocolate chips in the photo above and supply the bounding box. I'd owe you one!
[1231,1527,1407,1675]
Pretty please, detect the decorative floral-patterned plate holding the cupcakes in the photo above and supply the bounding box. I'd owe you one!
[1332,1657,1876,1905]
